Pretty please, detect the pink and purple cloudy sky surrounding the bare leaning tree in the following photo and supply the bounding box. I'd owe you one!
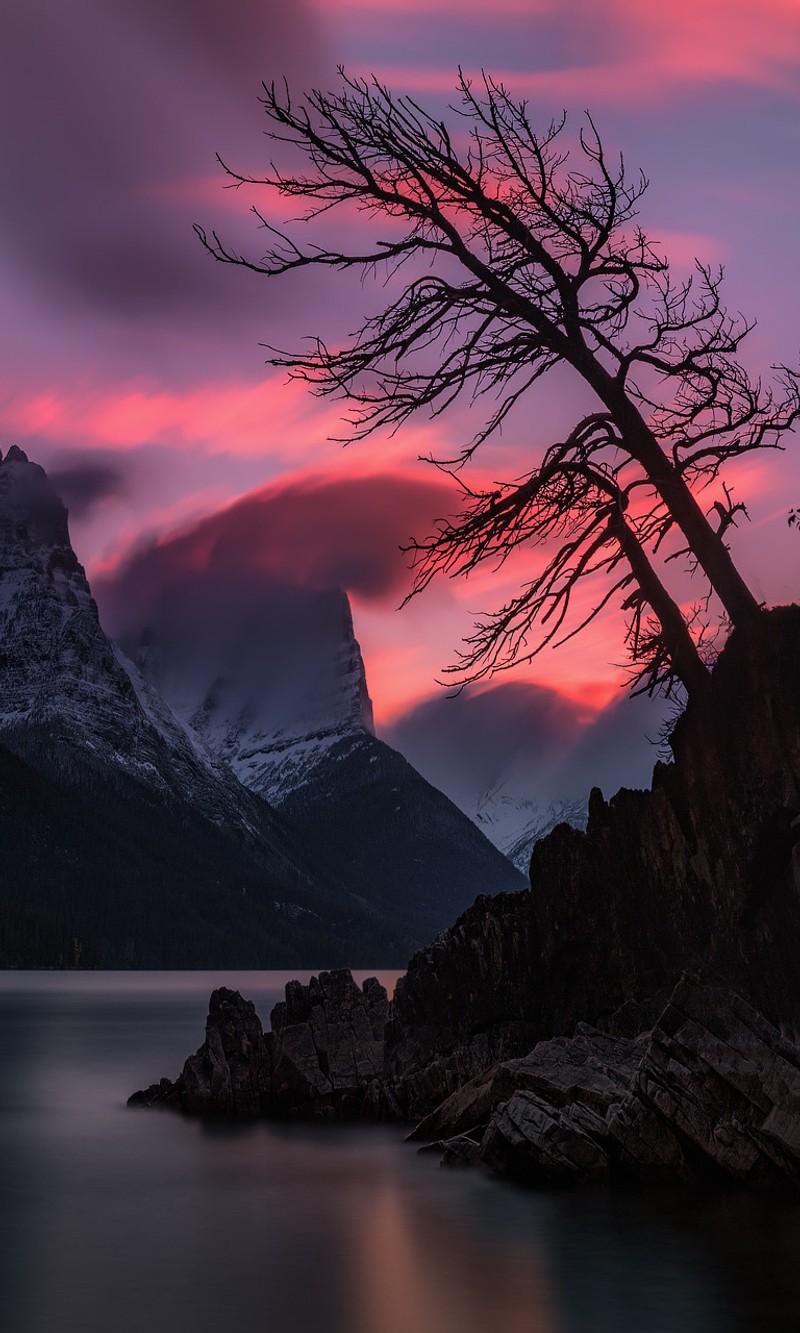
[0,0,800,721]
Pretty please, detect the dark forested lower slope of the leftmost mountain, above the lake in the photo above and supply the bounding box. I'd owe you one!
[0,746,412,968]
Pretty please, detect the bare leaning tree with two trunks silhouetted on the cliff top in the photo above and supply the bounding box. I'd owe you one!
[197,72,800,690]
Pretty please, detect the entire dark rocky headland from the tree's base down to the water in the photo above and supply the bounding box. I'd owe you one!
[131,608,800,1186]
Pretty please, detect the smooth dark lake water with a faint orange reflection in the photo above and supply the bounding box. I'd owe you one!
[0,973,800,1333]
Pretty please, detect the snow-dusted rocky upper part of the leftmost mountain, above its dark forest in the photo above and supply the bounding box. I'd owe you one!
[0,445,280,825]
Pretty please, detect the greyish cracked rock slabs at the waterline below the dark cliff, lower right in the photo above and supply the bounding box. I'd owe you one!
[480,973,800,1186]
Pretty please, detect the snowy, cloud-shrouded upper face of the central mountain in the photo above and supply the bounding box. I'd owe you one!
[123,572,373,805]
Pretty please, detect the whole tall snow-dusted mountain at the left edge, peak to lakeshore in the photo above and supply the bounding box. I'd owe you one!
[0,447,429,966]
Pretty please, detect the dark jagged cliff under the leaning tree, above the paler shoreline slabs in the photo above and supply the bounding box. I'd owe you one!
[378,607,800,1103]
